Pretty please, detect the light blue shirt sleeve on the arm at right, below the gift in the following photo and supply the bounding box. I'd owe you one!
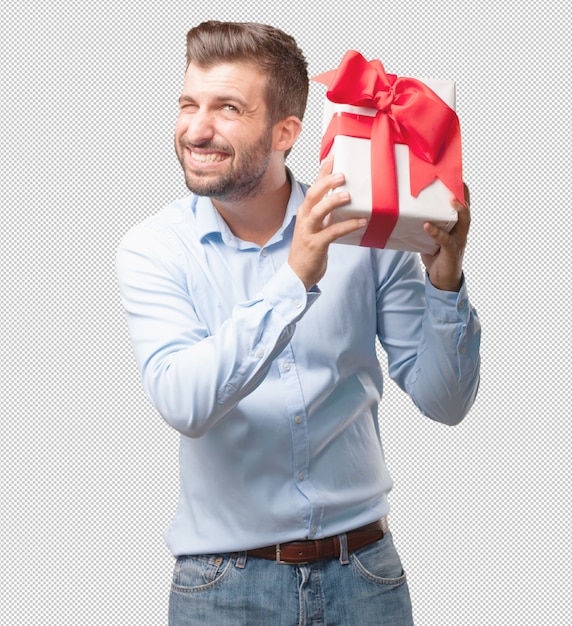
[378,250,481,425]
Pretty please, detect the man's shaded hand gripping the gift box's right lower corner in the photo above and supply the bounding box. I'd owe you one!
[421,185,471,291]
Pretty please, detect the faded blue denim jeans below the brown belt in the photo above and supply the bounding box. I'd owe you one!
[169,533,413,626]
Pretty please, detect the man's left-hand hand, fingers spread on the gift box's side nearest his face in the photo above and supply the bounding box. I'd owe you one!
[288,156,367,290]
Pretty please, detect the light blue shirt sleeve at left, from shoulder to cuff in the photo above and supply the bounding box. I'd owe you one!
[116,222,319,437]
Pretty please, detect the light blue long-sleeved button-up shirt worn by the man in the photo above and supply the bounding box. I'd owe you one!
[117,178,480,555]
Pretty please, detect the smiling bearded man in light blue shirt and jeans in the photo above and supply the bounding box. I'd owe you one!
[117,22,479,626]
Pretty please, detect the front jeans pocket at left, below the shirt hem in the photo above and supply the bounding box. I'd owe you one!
[172,554,232,592]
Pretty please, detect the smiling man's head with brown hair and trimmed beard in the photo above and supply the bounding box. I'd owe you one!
[175,22,308,201]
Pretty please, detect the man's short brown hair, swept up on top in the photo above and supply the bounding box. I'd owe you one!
[187,21,308,124]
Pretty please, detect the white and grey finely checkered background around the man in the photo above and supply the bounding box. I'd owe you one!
[0,0,571,626]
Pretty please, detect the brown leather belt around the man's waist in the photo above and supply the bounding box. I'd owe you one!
[247,517,388,565]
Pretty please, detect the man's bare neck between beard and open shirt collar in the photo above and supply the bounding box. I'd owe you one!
[213,165,291,247]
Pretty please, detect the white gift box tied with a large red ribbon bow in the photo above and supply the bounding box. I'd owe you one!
[313,50,464,254]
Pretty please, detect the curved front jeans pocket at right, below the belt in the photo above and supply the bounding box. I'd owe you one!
[351,532,406,585]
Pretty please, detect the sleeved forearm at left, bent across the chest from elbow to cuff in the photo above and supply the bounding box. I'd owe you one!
[141,292,294,437]
